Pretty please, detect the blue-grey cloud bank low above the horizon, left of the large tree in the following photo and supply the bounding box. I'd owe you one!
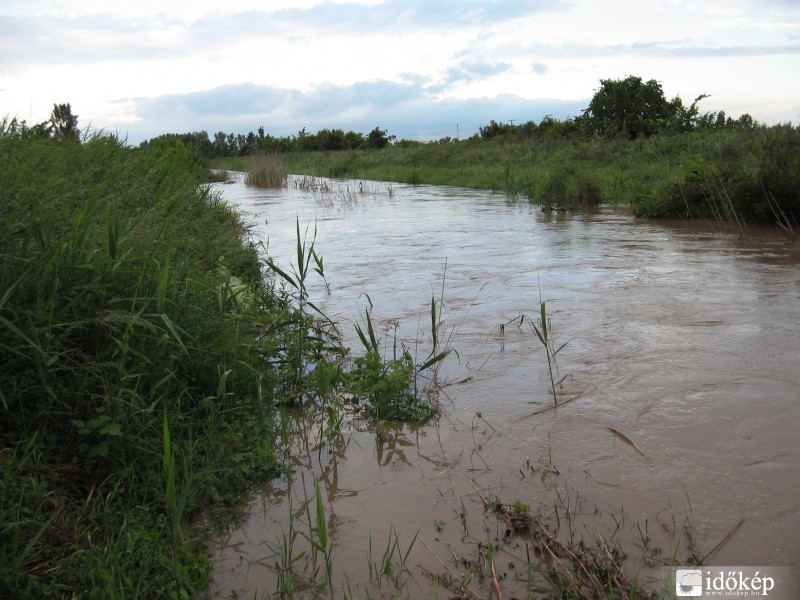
[128,81,588,144]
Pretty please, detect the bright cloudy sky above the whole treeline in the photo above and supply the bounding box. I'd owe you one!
[0,0,800,145]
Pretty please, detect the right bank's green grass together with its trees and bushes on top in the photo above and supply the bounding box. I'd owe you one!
[167,76,800,225]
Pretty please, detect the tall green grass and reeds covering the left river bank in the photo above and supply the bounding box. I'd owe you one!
[0,105,436,598]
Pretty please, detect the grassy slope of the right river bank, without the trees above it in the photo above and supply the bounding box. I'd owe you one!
[233,126,800,225]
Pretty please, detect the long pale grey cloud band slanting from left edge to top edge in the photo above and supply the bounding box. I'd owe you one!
[0,0,568,70]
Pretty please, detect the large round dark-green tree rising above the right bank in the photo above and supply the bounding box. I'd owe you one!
[584,75,677,138]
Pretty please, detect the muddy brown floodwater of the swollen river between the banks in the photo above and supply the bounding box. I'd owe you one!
[206,180,800,598]
